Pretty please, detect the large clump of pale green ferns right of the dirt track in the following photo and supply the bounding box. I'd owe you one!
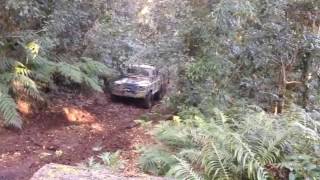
[140,107,320,179]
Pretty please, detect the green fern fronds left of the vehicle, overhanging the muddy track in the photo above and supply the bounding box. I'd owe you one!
[0,41,110,128]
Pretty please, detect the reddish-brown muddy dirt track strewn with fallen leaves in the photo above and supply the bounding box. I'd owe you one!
[0,93,152,180]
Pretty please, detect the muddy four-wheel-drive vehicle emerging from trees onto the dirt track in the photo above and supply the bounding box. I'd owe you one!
[110,65,169,108]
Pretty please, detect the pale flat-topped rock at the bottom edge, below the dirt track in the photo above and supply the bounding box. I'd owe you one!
[30,163,170,180]
